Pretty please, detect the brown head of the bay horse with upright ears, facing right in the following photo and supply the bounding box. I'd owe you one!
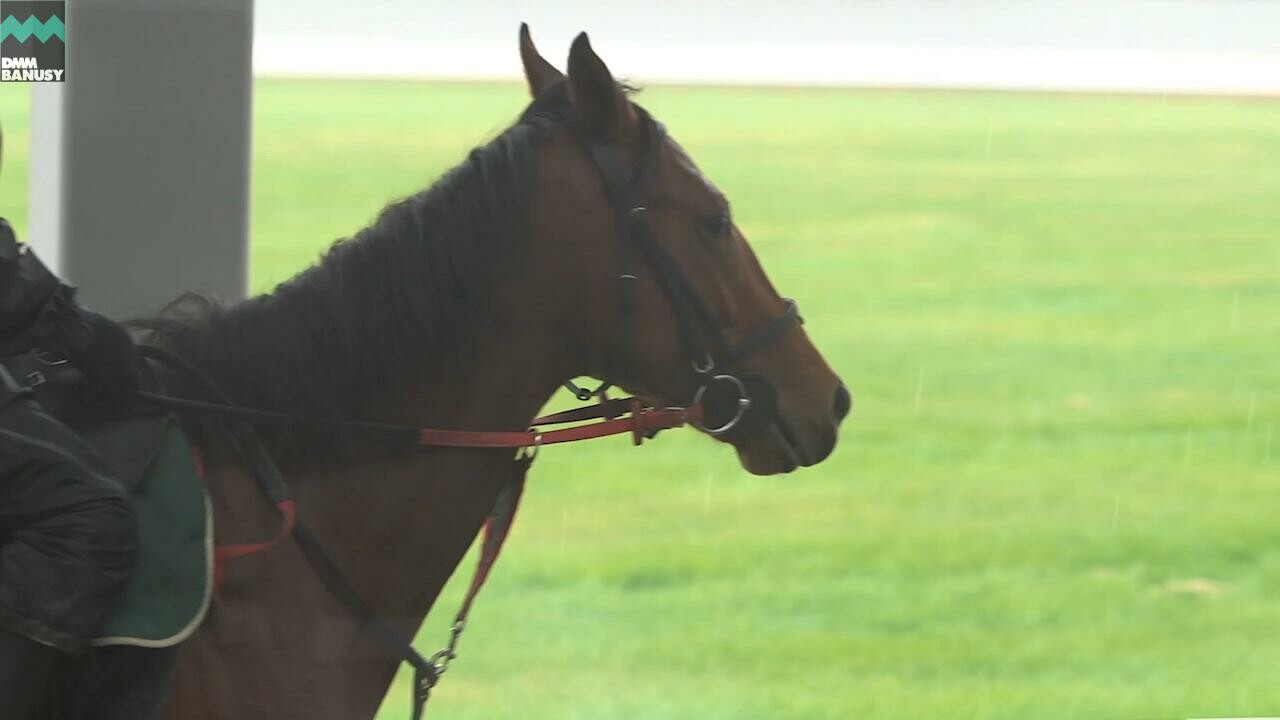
[520,26,850,474]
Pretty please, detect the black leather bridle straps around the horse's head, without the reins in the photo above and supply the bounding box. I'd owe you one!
[564,108,803,436]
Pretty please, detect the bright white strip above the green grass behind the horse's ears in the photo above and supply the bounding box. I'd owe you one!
[253,0,1280,95]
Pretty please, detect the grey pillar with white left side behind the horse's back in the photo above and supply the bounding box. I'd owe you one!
[29,0,253,319]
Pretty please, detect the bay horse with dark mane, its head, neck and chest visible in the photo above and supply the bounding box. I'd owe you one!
[152,26,850,720]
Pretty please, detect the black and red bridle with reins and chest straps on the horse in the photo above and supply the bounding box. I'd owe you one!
[138,87,803,720]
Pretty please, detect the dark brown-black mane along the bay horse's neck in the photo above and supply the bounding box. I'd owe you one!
[132,83,570,420]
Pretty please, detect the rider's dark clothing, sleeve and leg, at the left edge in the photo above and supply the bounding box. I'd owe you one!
[0,219,137,720]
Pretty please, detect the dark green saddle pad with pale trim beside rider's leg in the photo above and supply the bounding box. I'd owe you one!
[93,419,214,647]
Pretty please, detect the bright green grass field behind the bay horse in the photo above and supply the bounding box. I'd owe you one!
[0,81,1280,720]
